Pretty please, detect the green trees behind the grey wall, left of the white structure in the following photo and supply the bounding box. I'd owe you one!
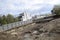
[0,14,21,25]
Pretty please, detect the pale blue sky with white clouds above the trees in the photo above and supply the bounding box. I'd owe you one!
[0,0,60,14]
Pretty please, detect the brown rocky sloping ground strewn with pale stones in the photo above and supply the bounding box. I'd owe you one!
[0,18,60,40]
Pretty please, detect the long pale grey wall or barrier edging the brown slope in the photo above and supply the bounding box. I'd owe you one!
[0,20,32,31]
